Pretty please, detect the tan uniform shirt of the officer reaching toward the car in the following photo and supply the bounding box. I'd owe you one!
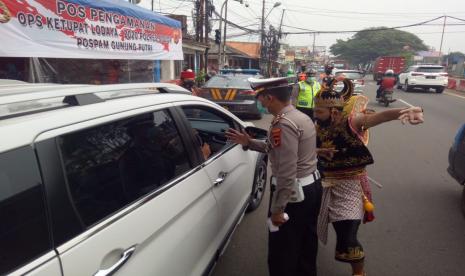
[249,105,317,213]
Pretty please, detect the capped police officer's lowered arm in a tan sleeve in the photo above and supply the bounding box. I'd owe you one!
[271,123,299,214]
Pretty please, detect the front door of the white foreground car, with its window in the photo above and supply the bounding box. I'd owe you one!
[181,105,258,244]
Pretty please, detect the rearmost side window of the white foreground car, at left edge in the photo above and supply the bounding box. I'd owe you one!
[0,147,52,275]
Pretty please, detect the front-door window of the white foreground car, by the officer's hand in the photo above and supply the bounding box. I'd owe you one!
[182,106,235,160]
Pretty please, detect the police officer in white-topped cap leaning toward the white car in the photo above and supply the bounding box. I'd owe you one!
[226,78,322,276]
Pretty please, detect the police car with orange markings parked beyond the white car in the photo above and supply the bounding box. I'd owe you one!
[197,69,262,119]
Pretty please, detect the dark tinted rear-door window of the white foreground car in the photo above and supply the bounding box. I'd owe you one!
[59,111,191,227]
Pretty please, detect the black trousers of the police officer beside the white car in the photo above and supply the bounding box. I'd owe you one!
[268,180,322,276]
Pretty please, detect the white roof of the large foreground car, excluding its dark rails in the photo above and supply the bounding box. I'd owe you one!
[0,83,232,152]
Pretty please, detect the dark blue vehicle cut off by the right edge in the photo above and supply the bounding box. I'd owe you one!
[447,124,465,214]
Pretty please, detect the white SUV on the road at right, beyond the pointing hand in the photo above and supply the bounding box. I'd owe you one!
[397,65,449,93]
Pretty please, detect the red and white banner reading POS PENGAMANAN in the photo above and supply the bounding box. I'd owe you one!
[0,0,183,60]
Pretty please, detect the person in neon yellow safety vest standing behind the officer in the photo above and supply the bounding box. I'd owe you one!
[293,69,320,120]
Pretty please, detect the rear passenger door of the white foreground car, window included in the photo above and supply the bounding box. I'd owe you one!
[36,108,219,276]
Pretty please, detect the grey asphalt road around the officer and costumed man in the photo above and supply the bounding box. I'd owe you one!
[213,82,465,276]
